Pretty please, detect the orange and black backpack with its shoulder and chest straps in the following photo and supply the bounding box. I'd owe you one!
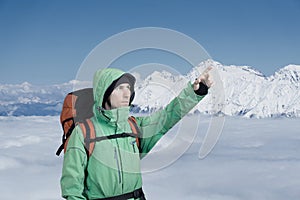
[56,88,140,156]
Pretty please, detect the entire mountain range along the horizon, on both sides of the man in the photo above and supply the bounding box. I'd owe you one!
[0,60,300,118]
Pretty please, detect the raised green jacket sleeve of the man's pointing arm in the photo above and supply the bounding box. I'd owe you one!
[136,83,205,157]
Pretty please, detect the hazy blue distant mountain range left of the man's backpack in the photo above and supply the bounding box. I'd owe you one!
[0,80,90,116]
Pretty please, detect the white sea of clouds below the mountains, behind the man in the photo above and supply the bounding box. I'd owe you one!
[0,115,300,200]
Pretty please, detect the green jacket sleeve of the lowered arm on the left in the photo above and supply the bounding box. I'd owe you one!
[60,126,87,200]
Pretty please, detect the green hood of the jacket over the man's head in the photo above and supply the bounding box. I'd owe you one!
[93,68,135,109]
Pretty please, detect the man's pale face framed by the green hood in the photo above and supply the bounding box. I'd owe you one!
[105,83,131,110]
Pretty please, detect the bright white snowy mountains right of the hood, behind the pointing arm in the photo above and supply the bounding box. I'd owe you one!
[134,60,300,118]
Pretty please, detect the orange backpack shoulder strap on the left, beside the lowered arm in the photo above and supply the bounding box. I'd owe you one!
[79,119,96,157]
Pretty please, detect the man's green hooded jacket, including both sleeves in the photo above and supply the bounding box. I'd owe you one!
[61,68,204,200]
